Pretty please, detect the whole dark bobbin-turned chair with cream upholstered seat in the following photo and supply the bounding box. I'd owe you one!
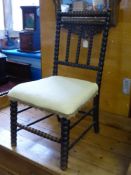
[8,11,110,170]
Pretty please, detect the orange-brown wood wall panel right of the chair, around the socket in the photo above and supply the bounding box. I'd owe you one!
[101,1,131,116]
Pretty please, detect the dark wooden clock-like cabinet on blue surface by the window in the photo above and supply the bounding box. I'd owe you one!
[19,6,40,52]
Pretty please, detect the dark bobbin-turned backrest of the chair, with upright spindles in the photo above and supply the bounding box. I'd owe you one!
[53,10,110,86]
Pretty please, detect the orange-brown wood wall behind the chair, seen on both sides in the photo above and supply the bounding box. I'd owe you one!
[40,0,131,117]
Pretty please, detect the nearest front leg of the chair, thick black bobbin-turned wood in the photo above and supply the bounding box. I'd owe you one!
[60,118,70,170]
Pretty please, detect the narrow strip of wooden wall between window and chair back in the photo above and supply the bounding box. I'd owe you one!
[40,0,56,77]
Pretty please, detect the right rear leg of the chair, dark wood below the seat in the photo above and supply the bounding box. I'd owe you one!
[93,95,100,133]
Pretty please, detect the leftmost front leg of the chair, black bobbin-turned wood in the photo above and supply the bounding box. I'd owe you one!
[10,101,17,146]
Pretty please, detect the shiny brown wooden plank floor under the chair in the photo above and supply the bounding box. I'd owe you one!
[0,105,131,175]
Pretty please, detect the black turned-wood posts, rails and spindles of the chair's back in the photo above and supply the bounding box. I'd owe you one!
[53,11,110,87]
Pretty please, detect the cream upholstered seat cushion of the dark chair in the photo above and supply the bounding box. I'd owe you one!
[8,76,98,117]
